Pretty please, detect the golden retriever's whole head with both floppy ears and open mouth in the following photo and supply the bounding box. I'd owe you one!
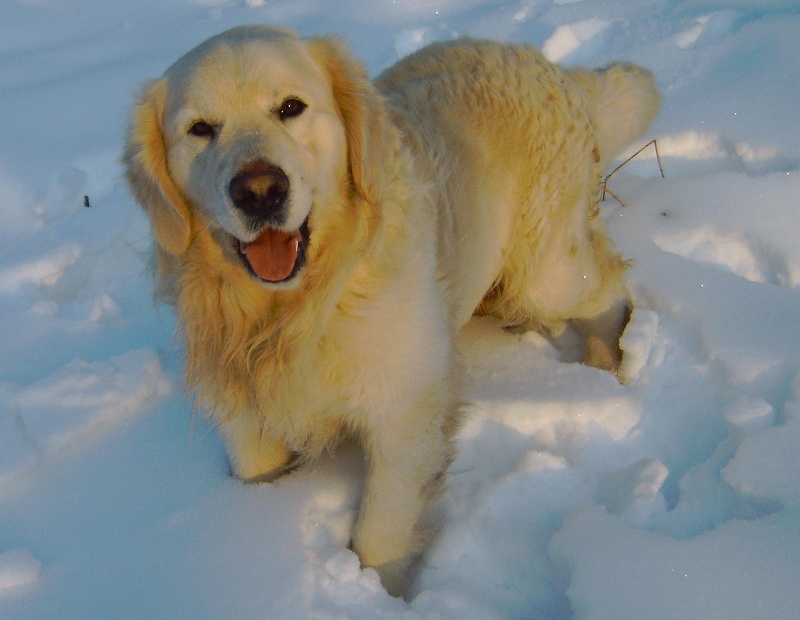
[125,26,385,289]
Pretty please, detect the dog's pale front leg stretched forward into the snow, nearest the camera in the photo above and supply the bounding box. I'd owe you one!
[353,388,456,596]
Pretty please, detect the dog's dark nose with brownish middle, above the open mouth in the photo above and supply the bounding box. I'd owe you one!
[228,162,289,224]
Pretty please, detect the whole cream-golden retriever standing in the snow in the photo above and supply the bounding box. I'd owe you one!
[124,26,659,594]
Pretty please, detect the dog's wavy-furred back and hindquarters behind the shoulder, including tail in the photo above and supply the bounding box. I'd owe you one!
[377,39,660,369]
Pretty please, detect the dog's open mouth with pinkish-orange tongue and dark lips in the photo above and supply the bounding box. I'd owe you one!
[235,219,309,284]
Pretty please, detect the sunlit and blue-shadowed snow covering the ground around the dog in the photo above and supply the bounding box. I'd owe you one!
[0,0,800,620]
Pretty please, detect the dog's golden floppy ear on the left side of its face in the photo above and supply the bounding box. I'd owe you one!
[123,79,191,256]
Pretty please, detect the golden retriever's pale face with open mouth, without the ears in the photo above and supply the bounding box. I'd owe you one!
[164,33,346,284]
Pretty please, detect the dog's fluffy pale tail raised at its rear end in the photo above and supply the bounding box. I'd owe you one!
[570,63,661,166]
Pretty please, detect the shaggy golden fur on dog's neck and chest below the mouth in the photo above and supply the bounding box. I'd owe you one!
[170,194,376,424]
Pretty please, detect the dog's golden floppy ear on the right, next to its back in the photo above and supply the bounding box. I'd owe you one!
[308,37,395,204]
